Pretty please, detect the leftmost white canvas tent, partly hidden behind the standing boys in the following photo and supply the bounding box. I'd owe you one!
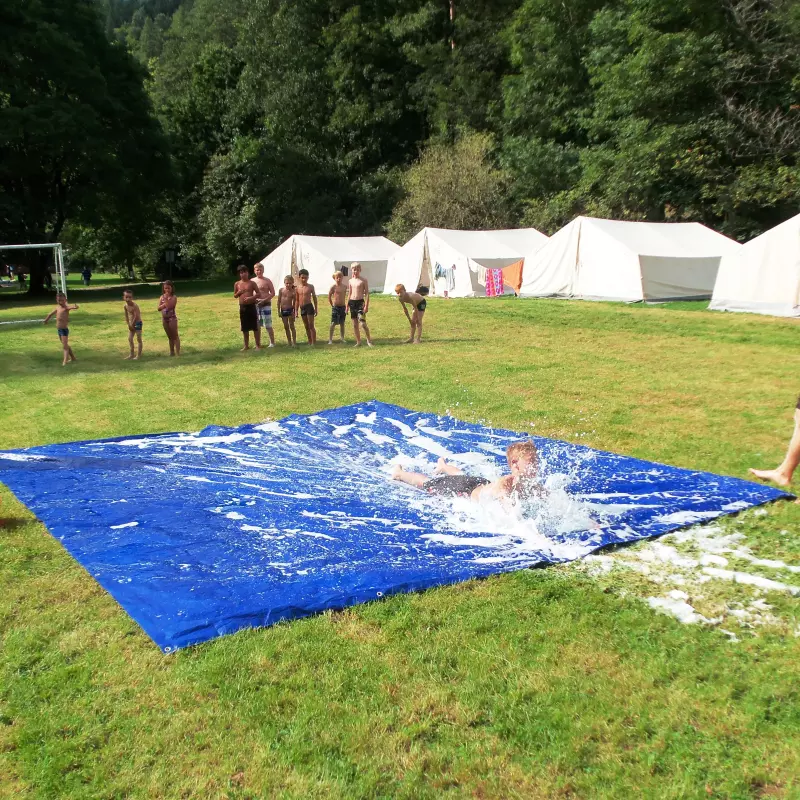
[261,234,400,294]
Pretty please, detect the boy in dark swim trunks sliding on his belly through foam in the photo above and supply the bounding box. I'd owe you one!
[392,441,544,502]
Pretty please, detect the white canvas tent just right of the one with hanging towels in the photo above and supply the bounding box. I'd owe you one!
[520,217,741,302]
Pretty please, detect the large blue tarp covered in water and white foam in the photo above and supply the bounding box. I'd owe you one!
[0,401,785,652]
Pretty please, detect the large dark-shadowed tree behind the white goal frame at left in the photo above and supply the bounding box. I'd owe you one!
[0,0,169,292]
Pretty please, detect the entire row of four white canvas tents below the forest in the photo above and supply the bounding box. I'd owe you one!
[261,214,800,316]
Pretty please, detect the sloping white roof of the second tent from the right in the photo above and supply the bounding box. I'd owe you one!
[576,217,741,258]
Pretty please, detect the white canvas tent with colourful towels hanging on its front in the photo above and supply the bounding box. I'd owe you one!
[385,228,547,297]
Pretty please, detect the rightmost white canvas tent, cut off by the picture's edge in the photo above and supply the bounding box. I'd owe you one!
[709,214,800,317]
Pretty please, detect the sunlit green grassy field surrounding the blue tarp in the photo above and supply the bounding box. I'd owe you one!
[0,283,800,798]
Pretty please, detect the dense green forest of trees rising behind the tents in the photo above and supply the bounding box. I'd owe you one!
[0,0,800,288]
